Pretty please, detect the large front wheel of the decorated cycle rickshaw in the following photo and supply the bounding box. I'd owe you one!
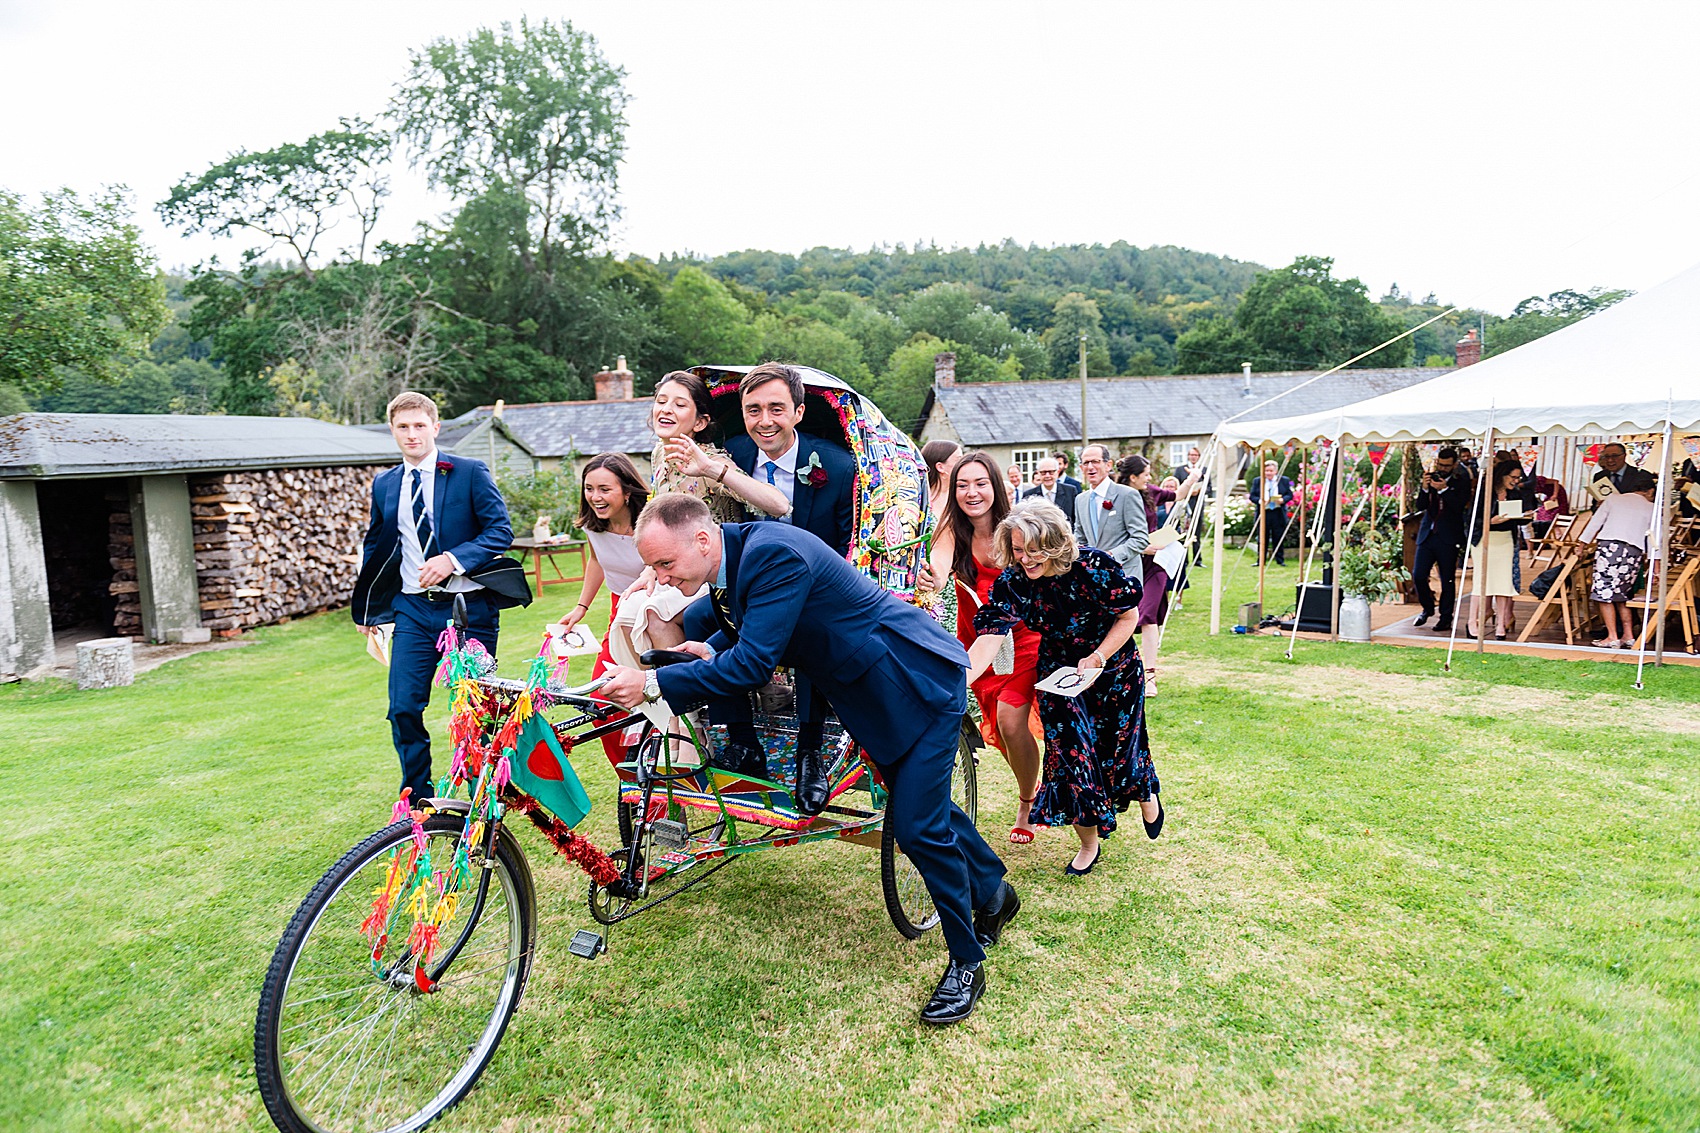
[253,815,537,1133]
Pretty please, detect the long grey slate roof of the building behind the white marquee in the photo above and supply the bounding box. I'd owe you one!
[921,367,1442,447]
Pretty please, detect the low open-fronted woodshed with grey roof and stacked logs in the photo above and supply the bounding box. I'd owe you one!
[0,413,398,680]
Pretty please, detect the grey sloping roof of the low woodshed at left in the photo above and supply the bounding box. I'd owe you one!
[0,413,401,480]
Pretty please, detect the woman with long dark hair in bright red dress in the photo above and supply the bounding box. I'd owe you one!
[932,453,1042,845]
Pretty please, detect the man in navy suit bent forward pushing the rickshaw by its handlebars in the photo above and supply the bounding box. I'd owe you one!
[602,493,1020,1024]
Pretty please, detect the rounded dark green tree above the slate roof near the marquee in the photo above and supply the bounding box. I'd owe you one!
[1175,255,1411,374]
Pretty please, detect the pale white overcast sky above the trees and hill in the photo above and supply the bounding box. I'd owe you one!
[0,0,1700,313]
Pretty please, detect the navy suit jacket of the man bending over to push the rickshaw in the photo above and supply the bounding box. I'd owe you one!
[656,522,967,764]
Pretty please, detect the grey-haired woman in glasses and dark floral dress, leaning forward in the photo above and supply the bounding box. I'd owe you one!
[969,504,1163,874]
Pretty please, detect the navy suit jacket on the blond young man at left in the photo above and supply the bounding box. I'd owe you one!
[349,453,513,626]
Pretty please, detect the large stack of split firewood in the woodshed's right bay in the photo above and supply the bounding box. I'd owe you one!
[189,466,381,636]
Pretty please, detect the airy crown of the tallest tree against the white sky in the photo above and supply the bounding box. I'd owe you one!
[391,19,626,277]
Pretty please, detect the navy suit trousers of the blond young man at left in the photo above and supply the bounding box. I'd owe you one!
[389,590,496,800]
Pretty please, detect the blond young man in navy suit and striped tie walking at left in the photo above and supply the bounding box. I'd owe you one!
[349,390,516,803]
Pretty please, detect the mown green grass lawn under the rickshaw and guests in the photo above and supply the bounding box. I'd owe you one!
[0,544,1700,1131]
